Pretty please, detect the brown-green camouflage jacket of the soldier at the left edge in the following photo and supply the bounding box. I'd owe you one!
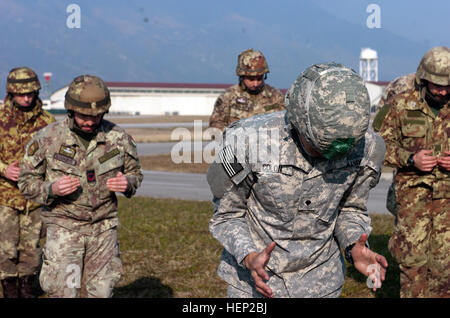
[0,98,55,211]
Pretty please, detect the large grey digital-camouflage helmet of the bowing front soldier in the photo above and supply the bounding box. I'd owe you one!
[285,62,370,159]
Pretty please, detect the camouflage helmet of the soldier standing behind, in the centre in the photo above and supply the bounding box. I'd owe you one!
[236,49,269,76]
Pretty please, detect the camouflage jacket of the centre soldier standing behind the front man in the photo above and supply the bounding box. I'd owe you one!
[209,84,285,130]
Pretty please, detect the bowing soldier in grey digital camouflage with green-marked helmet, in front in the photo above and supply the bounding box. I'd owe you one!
[208,63,387,297]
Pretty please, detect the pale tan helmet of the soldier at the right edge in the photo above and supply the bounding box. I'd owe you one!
[416,46,450,86]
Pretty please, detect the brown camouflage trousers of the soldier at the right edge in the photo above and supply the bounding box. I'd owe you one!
[389,186,450,297]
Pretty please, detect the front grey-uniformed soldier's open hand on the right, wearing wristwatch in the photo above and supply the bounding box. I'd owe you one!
[351,233,388,291]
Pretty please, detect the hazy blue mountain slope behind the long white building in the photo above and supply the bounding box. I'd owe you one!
[0,0,429,95]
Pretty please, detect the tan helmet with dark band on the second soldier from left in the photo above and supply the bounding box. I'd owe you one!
[64,75,111,116]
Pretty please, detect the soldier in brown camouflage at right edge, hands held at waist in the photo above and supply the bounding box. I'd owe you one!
[380,47,450,297]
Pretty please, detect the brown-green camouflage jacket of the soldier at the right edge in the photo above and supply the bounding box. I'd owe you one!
[380,89,450,199]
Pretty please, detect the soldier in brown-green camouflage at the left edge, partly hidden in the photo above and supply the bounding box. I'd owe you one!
[0,67,55,298]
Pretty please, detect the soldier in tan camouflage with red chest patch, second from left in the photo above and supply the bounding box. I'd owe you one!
[19,75,143,297]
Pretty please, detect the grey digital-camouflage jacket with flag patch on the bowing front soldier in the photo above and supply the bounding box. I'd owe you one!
[208,112,385,297]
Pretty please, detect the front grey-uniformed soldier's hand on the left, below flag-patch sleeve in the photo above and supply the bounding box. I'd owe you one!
[244,242,276,298]
